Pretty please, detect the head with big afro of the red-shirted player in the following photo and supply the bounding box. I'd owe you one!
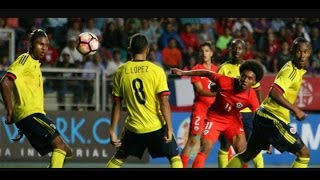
[240,60,264,89]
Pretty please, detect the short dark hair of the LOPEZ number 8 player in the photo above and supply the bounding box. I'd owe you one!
[128,33,149,55]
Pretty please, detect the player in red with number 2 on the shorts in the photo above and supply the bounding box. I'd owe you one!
[181,42,218,168]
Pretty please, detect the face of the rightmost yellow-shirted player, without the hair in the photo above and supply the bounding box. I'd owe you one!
[294,43,311,69]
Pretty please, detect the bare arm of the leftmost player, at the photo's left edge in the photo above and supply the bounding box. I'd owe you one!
[1,73,16,124]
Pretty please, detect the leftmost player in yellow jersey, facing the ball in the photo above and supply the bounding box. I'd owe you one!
[1,29,72,168]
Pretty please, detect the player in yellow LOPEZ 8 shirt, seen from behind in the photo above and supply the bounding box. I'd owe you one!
[107,33,182,168]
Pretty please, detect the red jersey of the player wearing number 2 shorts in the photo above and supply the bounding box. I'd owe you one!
[191,63,218,106]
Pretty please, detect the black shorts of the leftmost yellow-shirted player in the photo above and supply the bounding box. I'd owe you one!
[16,113,60,156]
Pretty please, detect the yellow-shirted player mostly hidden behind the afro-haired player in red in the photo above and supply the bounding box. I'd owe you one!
[218,39,264,168]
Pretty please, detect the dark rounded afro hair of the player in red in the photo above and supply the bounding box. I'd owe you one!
[240,60,264,82]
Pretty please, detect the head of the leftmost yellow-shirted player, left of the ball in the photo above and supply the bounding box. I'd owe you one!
[29,29,49,60]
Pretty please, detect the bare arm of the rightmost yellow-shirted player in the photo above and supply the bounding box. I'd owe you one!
[269,84,306,120]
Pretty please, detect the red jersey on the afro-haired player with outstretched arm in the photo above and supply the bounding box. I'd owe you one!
[209,73,259,122]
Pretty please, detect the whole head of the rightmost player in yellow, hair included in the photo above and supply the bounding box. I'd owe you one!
[291,37,312,69]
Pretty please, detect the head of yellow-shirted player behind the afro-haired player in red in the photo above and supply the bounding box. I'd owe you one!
[230,39,246,63]
